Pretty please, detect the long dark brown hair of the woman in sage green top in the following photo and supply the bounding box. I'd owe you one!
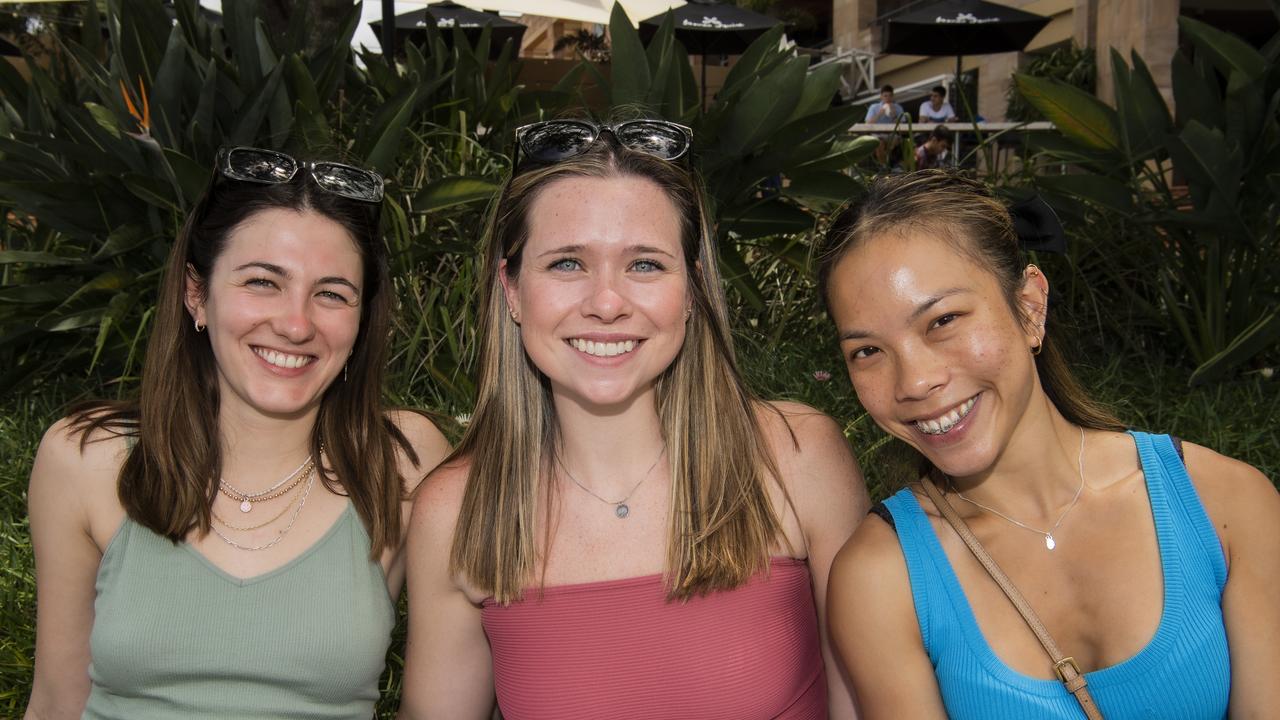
[72,161,417,557]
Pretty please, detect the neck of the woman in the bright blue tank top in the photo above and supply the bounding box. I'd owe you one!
[951,388,1088,521]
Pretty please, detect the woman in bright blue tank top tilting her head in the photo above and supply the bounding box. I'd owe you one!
[819,170,1280,720]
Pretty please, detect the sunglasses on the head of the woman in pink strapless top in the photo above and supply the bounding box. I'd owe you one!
[516,120,694,164]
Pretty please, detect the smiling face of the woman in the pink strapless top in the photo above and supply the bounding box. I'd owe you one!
[502,176,690,410]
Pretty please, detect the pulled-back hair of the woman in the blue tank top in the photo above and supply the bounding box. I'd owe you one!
[817,169,1125,479]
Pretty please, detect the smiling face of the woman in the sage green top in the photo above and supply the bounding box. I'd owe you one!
[187,209,364,418]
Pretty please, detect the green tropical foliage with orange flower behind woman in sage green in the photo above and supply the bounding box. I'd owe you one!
[0,0,545,393]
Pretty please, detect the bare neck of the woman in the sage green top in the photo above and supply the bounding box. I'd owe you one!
[219,394,319,492]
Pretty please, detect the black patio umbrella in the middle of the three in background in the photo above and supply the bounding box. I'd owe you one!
[640,0,782,105]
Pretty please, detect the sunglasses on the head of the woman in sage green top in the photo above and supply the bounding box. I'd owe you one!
[216,147,383,202]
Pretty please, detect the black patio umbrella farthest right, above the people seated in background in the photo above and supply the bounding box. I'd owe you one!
[882,0,1048,86]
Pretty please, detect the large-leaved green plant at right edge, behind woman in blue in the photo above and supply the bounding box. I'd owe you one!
[1015,17,1280,383]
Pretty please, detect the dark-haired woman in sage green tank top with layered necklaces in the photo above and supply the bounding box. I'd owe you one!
[27,147,448,720]
